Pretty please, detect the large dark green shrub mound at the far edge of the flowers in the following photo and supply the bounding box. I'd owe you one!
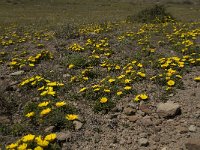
[127,5,174,23]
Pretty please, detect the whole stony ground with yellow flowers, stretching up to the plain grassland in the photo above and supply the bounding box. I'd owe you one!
[0,18,200,150]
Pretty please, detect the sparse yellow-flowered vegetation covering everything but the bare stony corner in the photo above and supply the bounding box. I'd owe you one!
[0,0,200,150]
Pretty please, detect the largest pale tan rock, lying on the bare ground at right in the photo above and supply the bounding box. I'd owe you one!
[157,101,181,118]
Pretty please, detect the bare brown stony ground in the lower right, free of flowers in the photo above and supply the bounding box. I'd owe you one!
[57,67,200,150]
